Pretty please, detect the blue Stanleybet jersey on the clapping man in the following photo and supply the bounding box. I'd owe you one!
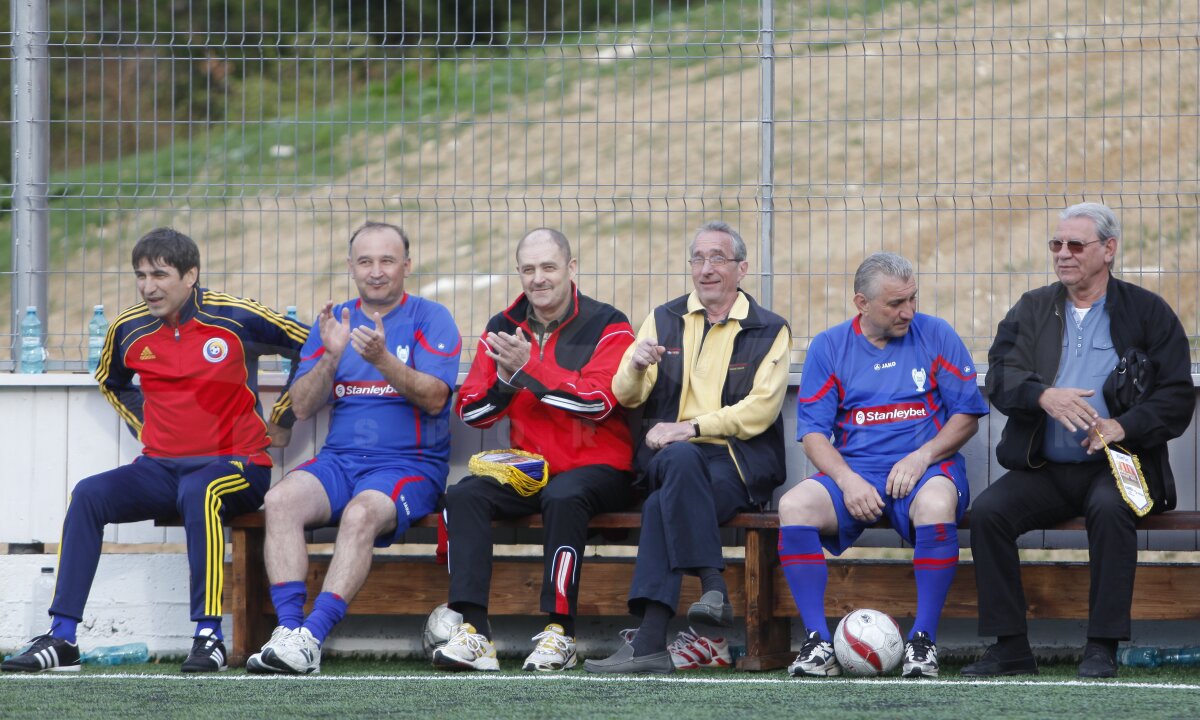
[296,294,462,468]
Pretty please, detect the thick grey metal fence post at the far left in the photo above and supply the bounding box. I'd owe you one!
[11,0,50,366]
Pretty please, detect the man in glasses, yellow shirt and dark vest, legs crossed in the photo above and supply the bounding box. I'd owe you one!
[586,222,792,673]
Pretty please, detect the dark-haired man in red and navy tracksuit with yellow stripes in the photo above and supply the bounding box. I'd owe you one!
[4,228,308,672]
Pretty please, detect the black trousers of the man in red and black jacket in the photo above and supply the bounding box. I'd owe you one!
[445,464,632,616]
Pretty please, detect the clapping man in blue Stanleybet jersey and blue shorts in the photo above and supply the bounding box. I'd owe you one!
[246,222,462,674]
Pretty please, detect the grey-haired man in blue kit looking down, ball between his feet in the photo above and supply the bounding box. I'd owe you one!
[779,253,988,678]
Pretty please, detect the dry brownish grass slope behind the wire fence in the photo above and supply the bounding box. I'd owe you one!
[58,0,1200,361]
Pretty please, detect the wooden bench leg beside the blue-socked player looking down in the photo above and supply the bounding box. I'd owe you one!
[738,528,792,671]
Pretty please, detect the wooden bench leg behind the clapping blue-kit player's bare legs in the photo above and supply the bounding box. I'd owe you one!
[229,528,272,666]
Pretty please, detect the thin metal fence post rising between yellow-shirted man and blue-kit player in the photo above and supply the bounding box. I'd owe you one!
[758,0,775,307]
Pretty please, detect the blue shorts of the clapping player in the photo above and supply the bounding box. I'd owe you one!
[293,452,442,547]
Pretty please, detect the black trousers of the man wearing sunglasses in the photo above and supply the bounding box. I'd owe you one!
[971,458,1138,640]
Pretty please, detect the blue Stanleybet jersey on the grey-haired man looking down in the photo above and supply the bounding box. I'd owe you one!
[796,313,988,470]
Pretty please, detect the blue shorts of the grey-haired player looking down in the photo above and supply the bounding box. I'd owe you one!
[812,452,971,556]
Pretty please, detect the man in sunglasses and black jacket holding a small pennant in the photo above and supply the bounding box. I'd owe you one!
[962,203,1194,678]
